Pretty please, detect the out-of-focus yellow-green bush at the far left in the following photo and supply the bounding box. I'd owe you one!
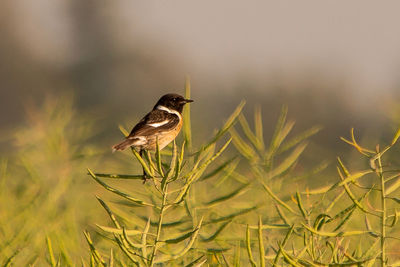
[0,96,103,266]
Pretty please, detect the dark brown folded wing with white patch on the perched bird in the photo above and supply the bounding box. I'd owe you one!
[128,109,180,139]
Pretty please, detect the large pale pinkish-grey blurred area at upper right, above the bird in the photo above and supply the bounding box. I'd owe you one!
[130,1,400,93]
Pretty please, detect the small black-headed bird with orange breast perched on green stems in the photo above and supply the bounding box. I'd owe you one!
[112,94,193,155]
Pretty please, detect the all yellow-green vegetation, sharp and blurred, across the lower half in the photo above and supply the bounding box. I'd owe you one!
[0,87,400,266]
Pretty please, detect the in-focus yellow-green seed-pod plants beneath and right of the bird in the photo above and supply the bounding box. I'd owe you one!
[89,89,400,266]
